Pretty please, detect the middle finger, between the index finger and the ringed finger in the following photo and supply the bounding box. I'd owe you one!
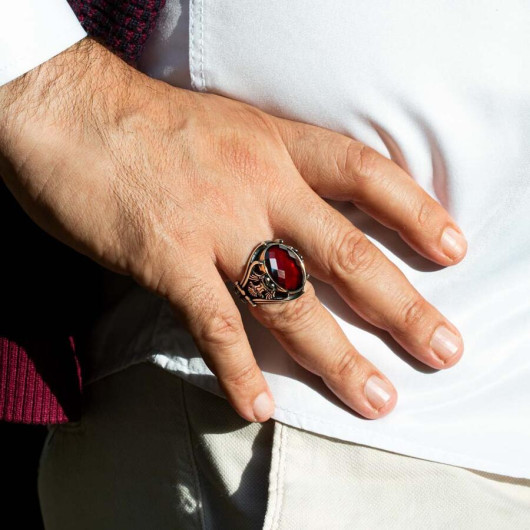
[271,186,463,369]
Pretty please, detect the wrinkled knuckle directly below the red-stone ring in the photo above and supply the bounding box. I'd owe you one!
[260,281,320,333]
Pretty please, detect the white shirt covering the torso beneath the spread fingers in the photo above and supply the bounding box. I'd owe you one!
[4,0,530,478]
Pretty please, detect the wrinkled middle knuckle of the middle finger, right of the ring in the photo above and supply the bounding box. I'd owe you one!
[330,229,377,278]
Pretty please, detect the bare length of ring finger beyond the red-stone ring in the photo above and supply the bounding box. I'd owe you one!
[248,281,397,419]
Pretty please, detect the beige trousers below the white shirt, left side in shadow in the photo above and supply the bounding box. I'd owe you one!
[38,362,530,530]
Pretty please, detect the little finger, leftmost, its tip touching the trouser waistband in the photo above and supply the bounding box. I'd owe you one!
[164,251,274,422]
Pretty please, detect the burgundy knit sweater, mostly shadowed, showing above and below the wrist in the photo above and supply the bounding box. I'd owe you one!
[0,0,165,424]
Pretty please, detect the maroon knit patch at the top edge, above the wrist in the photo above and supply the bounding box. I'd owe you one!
[68,0,165,65]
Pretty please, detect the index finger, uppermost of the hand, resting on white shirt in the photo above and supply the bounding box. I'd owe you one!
[275,118,467,265]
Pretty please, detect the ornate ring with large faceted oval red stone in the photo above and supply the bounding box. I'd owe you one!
[235,239,310,307]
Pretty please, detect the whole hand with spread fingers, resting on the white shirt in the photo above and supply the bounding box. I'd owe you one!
[0,38,466,421]
